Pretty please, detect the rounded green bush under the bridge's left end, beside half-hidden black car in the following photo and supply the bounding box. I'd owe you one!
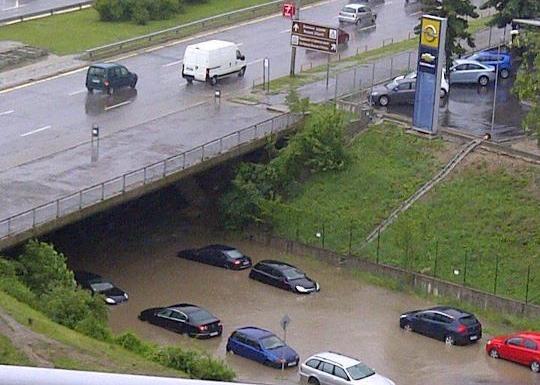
[18,240,75,296]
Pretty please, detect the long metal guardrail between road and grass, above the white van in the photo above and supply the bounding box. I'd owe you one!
[84,0,286,59]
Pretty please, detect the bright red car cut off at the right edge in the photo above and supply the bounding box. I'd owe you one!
[486,332,540,373]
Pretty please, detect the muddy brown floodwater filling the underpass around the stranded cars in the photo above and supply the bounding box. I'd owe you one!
[45,184,540,385]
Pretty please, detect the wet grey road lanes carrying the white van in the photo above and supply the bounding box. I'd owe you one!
[0,0,419,170]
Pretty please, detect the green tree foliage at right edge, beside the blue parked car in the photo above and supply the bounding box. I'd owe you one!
[514,31,540,146]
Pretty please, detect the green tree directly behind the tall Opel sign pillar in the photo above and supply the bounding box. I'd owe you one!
[415,0,478,70]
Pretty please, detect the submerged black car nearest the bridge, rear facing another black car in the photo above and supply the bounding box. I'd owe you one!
[178,245,251,270]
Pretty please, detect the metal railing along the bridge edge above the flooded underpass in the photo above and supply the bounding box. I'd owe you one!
[0,114,302,240]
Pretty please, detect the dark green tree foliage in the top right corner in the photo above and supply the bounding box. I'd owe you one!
[480,0,540,28]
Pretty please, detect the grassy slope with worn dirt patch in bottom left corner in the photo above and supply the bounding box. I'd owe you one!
[0,291,186,377]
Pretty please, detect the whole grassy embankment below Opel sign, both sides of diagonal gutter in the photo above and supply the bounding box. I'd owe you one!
[271,127,540,303]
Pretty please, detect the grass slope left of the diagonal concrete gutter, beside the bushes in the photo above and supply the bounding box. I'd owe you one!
[269,124,445,252]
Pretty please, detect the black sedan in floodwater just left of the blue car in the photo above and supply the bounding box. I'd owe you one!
[139,303,223,338]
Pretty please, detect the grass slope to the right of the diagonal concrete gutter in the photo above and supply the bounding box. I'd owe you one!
[362,161,540,304]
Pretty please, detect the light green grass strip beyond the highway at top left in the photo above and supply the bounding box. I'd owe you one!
[0,0,286,55]
